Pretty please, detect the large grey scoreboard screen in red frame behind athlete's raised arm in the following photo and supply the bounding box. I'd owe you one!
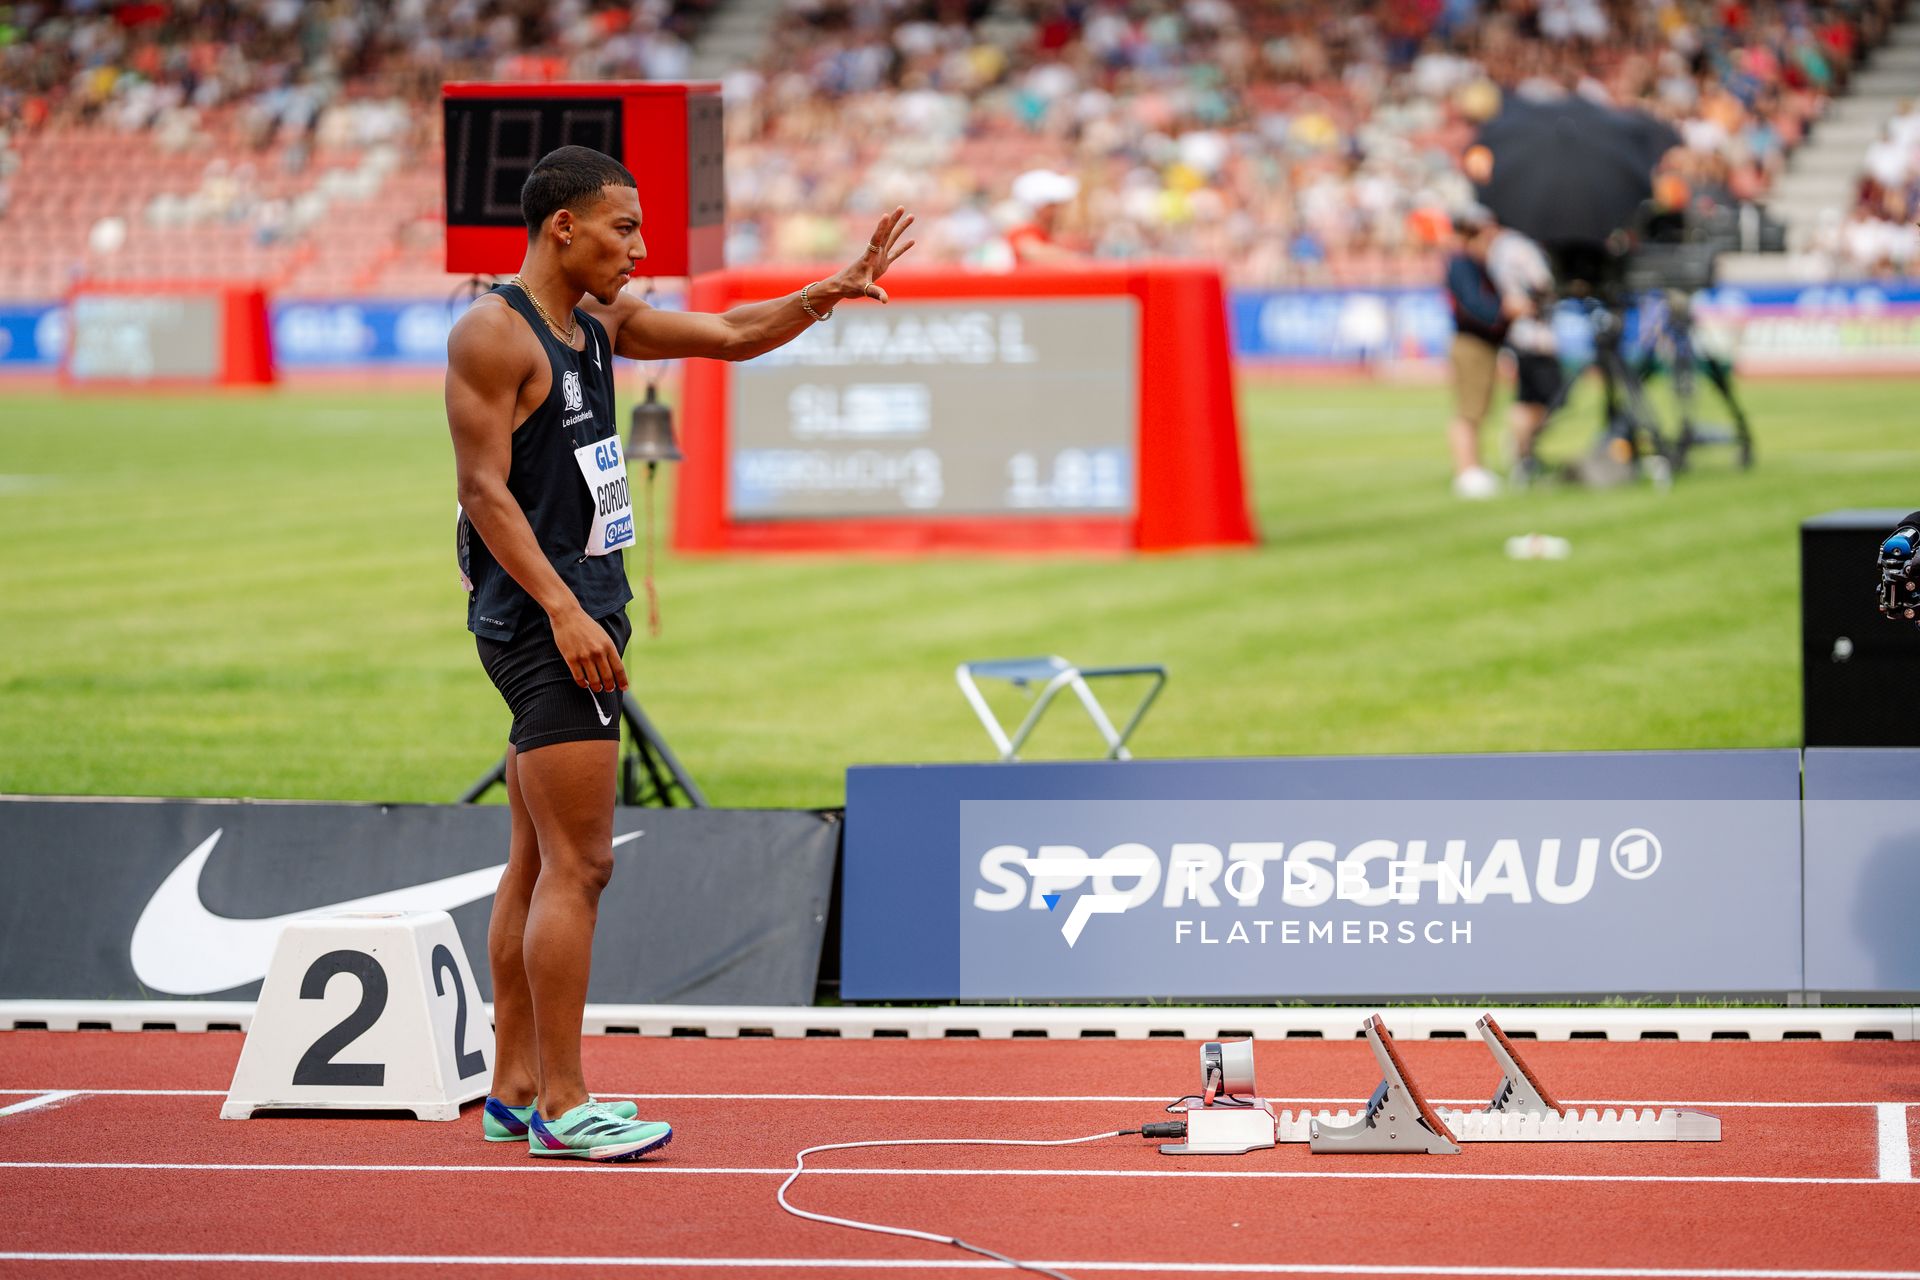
[728,297,1139,520]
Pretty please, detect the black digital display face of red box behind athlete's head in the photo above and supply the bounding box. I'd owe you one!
[444,98,626,226]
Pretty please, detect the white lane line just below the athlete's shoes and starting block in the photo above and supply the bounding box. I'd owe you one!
[0,1159,1882,1186]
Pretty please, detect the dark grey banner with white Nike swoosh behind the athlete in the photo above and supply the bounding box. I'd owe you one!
[0,798,839,1004]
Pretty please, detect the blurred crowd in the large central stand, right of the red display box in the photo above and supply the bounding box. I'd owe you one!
[728,0,1895,284]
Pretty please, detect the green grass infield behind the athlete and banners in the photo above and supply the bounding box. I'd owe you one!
[0,380,1920,806]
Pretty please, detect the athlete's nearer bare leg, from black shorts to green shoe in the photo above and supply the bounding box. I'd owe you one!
[516,739,620,1115]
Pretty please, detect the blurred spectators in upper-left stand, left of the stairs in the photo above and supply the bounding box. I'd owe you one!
[0,0,718,238]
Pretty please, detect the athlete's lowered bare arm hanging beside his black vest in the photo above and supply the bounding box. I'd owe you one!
[447,305,626,693]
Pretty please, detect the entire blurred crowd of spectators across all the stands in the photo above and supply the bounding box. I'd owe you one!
[0,0,1920,286]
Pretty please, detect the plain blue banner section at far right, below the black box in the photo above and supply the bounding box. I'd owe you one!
[1807,747,1920,1000]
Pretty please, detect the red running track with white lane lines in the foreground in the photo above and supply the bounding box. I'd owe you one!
[0,1032,1920,1280]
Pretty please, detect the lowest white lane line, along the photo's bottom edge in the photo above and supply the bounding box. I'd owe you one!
[0,1253,1920,1280]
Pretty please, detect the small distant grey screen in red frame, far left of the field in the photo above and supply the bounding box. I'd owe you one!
[69,294,221,382]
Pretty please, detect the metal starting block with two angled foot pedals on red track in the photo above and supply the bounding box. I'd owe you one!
[1160,1015,1720,1155]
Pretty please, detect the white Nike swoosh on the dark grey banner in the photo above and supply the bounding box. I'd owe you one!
[129,827,645,996]
